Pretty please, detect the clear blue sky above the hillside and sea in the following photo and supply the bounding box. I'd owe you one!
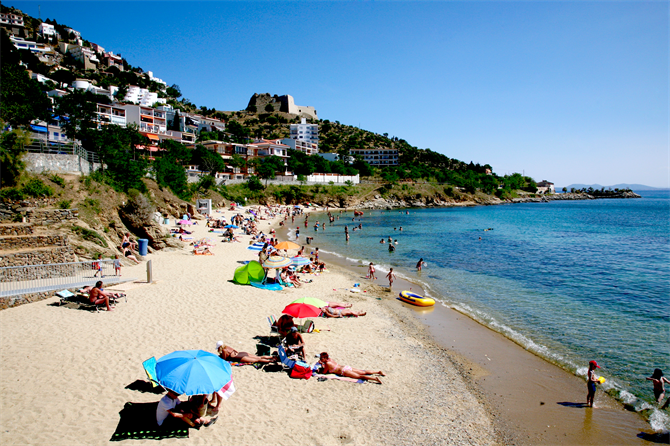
[10,0,670,188]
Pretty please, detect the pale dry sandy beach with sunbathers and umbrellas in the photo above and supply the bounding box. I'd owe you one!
[0,211,498,445]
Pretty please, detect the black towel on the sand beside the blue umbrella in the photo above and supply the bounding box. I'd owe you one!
[110,401,188,441]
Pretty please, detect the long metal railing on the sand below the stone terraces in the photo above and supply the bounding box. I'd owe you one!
[0,260,130,297]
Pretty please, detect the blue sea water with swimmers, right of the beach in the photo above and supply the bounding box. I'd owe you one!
[290,191,670,430]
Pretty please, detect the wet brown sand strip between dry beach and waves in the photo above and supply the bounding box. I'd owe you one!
[292,209,667,445]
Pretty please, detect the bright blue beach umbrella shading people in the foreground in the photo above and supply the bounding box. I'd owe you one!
[156,350,232,395]
